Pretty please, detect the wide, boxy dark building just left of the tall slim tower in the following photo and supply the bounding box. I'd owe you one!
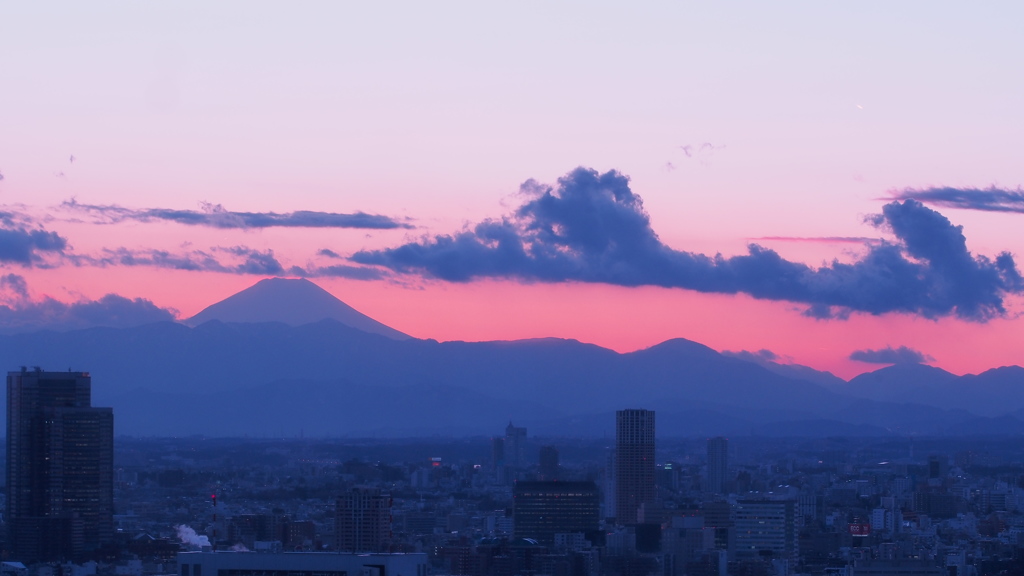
[512,481,601,546]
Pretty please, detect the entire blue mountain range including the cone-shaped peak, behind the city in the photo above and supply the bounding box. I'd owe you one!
[0,279,1024,437]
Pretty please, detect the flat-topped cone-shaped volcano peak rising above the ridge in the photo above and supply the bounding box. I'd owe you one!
[184,278,410,340]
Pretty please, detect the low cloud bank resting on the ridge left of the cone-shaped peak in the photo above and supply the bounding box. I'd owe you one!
[0,274,175,334]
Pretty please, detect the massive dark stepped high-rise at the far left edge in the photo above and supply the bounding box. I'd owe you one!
[7,368,114,563]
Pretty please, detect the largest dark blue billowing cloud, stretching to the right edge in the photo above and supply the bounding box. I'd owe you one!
[351,167,1024,322]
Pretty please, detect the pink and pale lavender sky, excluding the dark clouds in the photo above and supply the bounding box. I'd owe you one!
[0,2,1024,377]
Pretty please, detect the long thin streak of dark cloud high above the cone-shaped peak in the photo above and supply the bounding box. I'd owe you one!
[60,199,412,230]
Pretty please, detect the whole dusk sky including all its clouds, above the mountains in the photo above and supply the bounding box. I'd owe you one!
[0,2,1024,377]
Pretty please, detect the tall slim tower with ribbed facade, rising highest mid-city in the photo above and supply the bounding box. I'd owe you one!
[615,409,656,524]
